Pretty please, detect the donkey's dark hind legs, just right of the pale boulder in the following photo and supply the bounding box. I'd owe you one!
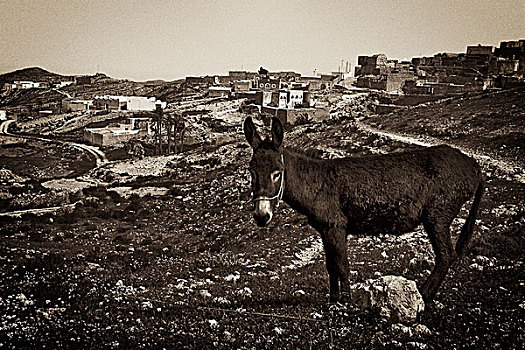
[419,218,456,302]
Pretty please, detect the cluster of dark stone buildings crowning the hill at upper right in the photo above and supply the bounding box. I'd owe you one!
[355,40,525,95]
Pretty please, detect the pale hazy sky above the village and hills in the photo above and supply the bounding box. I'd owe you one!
[0,0,525,80]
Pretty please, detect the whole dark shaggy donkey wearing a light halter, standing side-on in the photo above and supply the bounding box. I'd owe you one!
[244,117,483,301]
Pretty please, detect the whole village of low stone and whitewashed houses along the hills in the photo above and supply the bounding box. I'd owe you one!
[0,40,525,150]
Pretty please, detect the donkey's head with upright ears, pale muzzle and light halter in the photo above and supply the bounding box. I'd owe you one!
[244,117,284,226]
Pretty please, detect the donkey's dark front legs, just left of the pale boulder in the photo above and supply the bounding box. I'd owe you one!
[321,229,350,302]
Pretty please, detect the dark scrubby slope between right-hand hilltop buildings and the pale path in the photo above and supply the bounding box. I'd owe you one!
[367,88,525,169]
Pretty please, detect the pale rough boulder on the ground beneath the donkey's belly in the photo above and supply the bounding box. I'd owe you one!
[350,276,425,323]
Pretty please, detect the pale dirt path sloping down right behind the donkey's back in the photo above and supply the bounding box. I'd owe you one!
[356,121,525,183]
